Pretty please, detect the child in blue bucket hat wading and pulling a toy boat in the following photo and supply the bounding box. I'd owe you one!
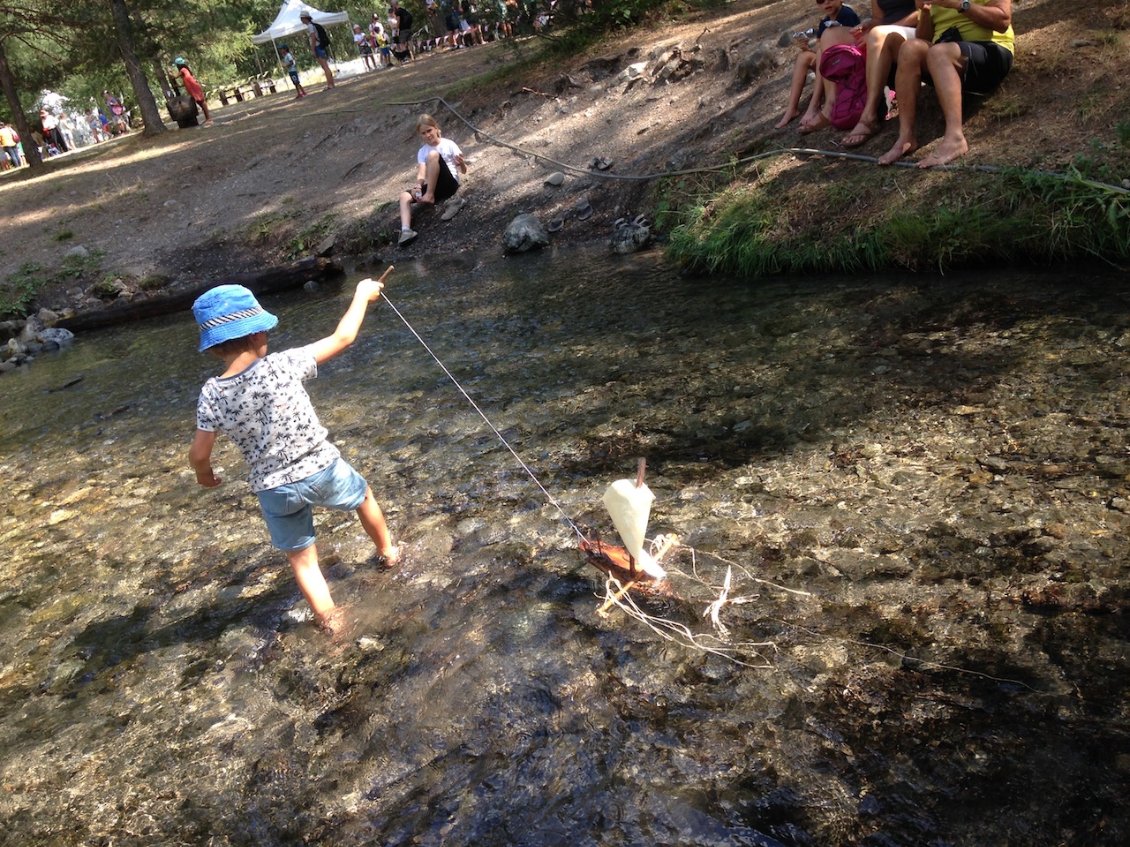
[189,279,399,632]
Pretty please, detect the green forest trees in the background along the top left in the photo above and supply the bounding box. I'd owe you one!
[0,0,661,168]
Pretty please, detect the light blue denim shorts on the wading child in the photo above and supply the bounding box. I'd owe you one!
[259,459,368,552]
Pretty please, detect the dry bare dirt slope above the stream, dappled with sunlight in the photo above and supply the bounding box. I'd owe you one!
[0,0,1130,313]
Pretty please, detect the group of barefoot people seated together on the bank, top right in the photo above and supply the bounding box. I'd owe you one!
[776,0,1015,168]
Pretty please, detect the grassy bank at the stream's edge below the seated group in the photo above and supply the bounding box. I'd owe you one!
[655,137,1130,277]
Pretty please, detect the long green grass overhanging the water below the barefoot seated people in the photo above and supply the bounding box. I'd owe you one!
[657,158,1130,278]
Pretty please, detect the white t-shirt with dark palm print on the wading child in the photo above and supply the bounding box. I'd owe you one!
[197,347,341,492]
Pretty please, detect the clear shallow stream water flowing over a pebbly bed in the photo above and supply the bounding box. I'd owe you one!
[0,252,1130,847]
